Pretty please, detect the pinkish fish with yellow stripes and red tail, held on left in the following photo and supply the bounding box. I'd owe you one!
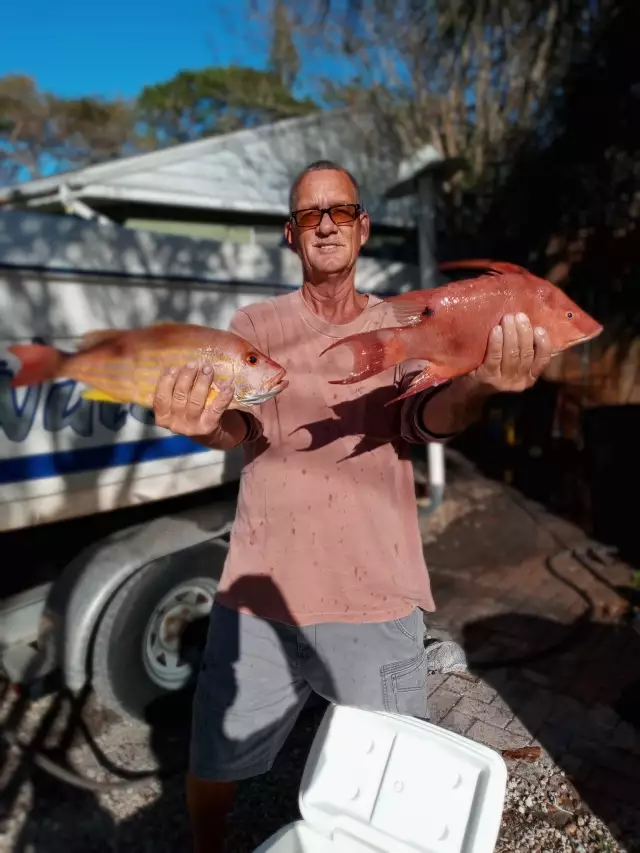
[9,323,286,409]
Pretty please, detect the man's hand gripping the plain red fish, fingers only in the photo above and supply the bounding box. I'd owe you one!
[469,314,552,394]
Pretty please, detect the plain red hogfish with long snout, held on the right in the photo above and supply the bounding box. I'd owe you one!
[322,261,602,402]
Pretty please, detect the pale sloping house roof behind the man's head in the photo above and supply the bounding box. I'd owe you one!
[0,110,450,227]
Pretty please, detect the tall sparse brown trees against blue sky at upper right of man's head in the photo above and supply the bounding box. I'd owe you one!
[260,0,613,234]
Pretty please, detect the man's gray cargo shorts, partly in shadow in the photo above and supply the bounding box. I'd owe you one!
[189,604,428,782]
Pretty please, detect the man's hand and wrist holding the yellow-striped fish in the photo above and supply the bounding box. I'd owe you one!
[153,364,247,450]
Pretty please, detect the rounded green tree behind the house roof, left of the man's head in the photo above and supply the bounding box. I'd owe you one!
[137,65,317,145]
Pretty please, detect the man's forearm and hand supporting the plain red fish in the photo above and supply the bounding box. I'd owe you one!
[409,314,551,441]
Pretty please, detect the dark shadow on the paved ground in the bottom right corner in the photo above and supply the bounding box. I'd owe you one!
[463,610,640,851]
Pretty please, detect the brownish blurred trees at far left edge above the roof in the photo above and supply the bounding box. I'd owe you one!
[0,75,136,184]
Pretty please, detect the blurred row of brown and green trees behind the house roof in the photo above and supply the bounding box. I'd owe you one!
[0,63,318,185]
